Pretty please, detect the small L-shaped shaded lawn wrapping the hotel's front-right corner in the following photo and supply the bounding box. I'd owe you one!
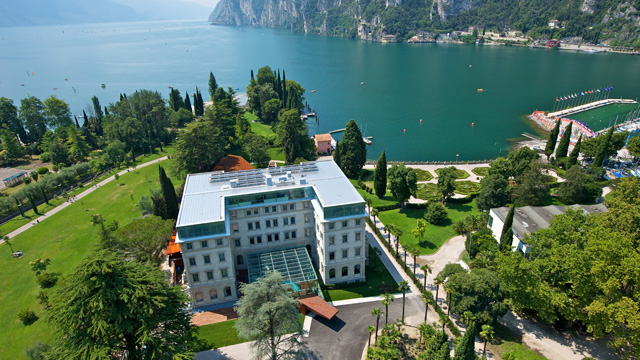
[323,246,398,301]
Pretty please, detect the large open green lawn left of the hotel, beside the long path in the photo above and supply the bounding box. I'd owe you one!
[0,162,170,359]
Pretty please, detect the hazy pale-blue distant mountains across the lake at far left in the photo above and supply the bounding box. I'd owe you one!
[0,0,211,27]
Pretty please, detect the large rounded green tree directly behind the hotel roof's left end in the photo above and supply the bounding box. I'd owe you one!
[174,121,226,174]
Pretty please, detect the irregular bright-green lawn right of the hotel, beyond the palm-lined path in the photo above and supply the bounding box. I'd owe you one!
[378,200,480,255]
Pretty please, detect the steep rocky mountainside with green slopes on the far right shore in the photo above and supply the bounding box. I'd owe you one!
[209,0,640,47]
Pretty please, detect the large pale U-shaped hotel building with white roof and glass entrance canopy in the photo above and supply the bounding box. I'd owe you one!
[176,160,368,308]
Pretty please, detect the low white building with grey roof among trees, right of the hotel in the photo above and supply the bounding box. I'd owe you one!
[488,204,607,254]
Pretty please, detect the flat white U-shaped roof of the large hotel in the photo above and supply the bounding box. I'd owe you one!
[176,160,364,227]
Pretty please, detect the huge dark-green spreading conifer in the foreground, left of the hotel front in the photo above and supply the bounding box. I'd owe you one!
[48,250,195,359]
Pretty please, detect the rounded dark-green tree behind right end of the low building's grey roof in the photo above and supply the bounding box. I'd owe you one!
[558,165,602,204]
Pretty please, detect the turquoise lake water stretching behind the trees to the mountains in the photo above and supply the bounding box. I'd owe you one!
[0,21,640,161]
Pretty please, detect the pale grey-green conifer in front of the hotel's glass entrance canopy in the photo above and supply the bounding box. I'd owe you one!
[234,271,308,360]
